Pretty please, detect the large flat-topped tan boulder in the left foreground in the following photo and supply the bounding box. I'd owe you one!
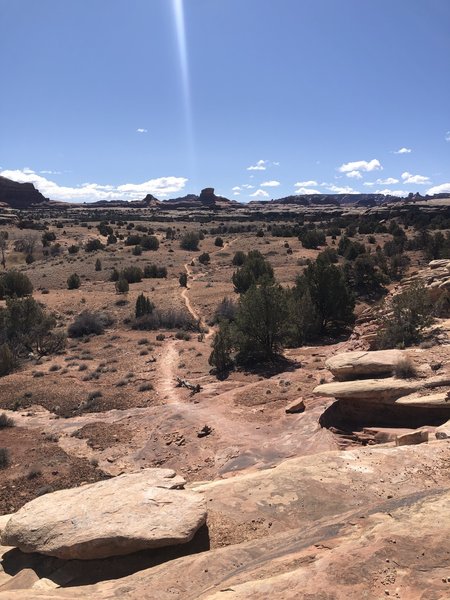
[1,469,206,560]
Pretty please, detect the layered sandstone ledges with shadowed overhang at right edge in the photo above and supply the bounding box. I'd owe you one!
[314,350,450,429]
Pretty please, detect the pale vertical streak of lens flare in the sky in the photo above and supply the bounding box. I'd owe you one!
[172,0,194,178]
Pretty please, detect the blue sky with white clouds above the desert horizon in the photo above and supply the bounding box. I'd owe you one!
[0,0,450,202]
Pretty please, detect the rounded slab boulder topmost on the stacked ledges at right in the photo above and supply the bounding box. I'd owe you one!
[325,350,408,381]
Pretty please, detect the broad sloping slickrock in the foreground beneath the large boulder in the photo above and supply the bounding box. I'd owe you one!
[0,441,450,600]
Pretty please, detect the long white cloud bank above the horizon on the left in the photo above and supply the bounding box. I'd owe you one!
[0,168,188,202]
